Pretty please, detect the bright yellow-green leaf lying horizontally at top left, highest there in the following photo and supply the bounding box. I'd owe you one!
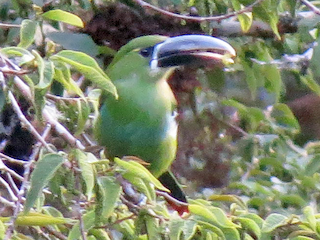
[41,9,84,28]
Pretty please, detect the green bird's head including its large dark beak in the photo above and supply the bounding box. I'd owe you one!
[109,35,236,79]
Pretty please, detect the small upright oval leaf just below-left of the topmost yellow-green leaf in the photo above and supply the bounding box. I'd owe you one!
[18,19,37,48]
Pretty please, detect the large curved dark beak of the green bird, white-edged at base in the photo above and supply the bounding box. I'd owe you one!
[151,35,236,67]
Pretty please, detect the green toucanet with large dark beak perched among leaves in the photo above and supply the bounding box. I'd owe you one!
[94,35,236,211]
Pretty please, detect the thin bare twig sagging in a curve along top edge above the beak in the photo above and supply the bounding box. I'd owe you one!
[134,0,264,22]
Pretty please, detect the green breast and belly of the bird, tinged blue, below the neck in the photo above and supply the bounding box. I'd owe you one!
[96,77,177,172]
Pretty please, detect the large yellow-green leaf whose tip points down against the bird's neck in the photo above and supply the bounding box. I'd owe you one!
[50,50,118,97]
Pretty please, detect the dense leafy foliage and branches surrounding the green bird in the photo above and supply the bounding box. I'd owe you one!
[0,0,320,240]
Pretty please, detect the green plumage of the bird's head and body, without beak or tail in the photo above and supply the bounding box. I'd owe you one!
[95,36,177,177]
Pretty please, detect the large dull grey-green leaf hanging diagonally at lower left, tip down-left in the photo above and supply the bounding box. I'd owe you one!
[24,153,64,213]
